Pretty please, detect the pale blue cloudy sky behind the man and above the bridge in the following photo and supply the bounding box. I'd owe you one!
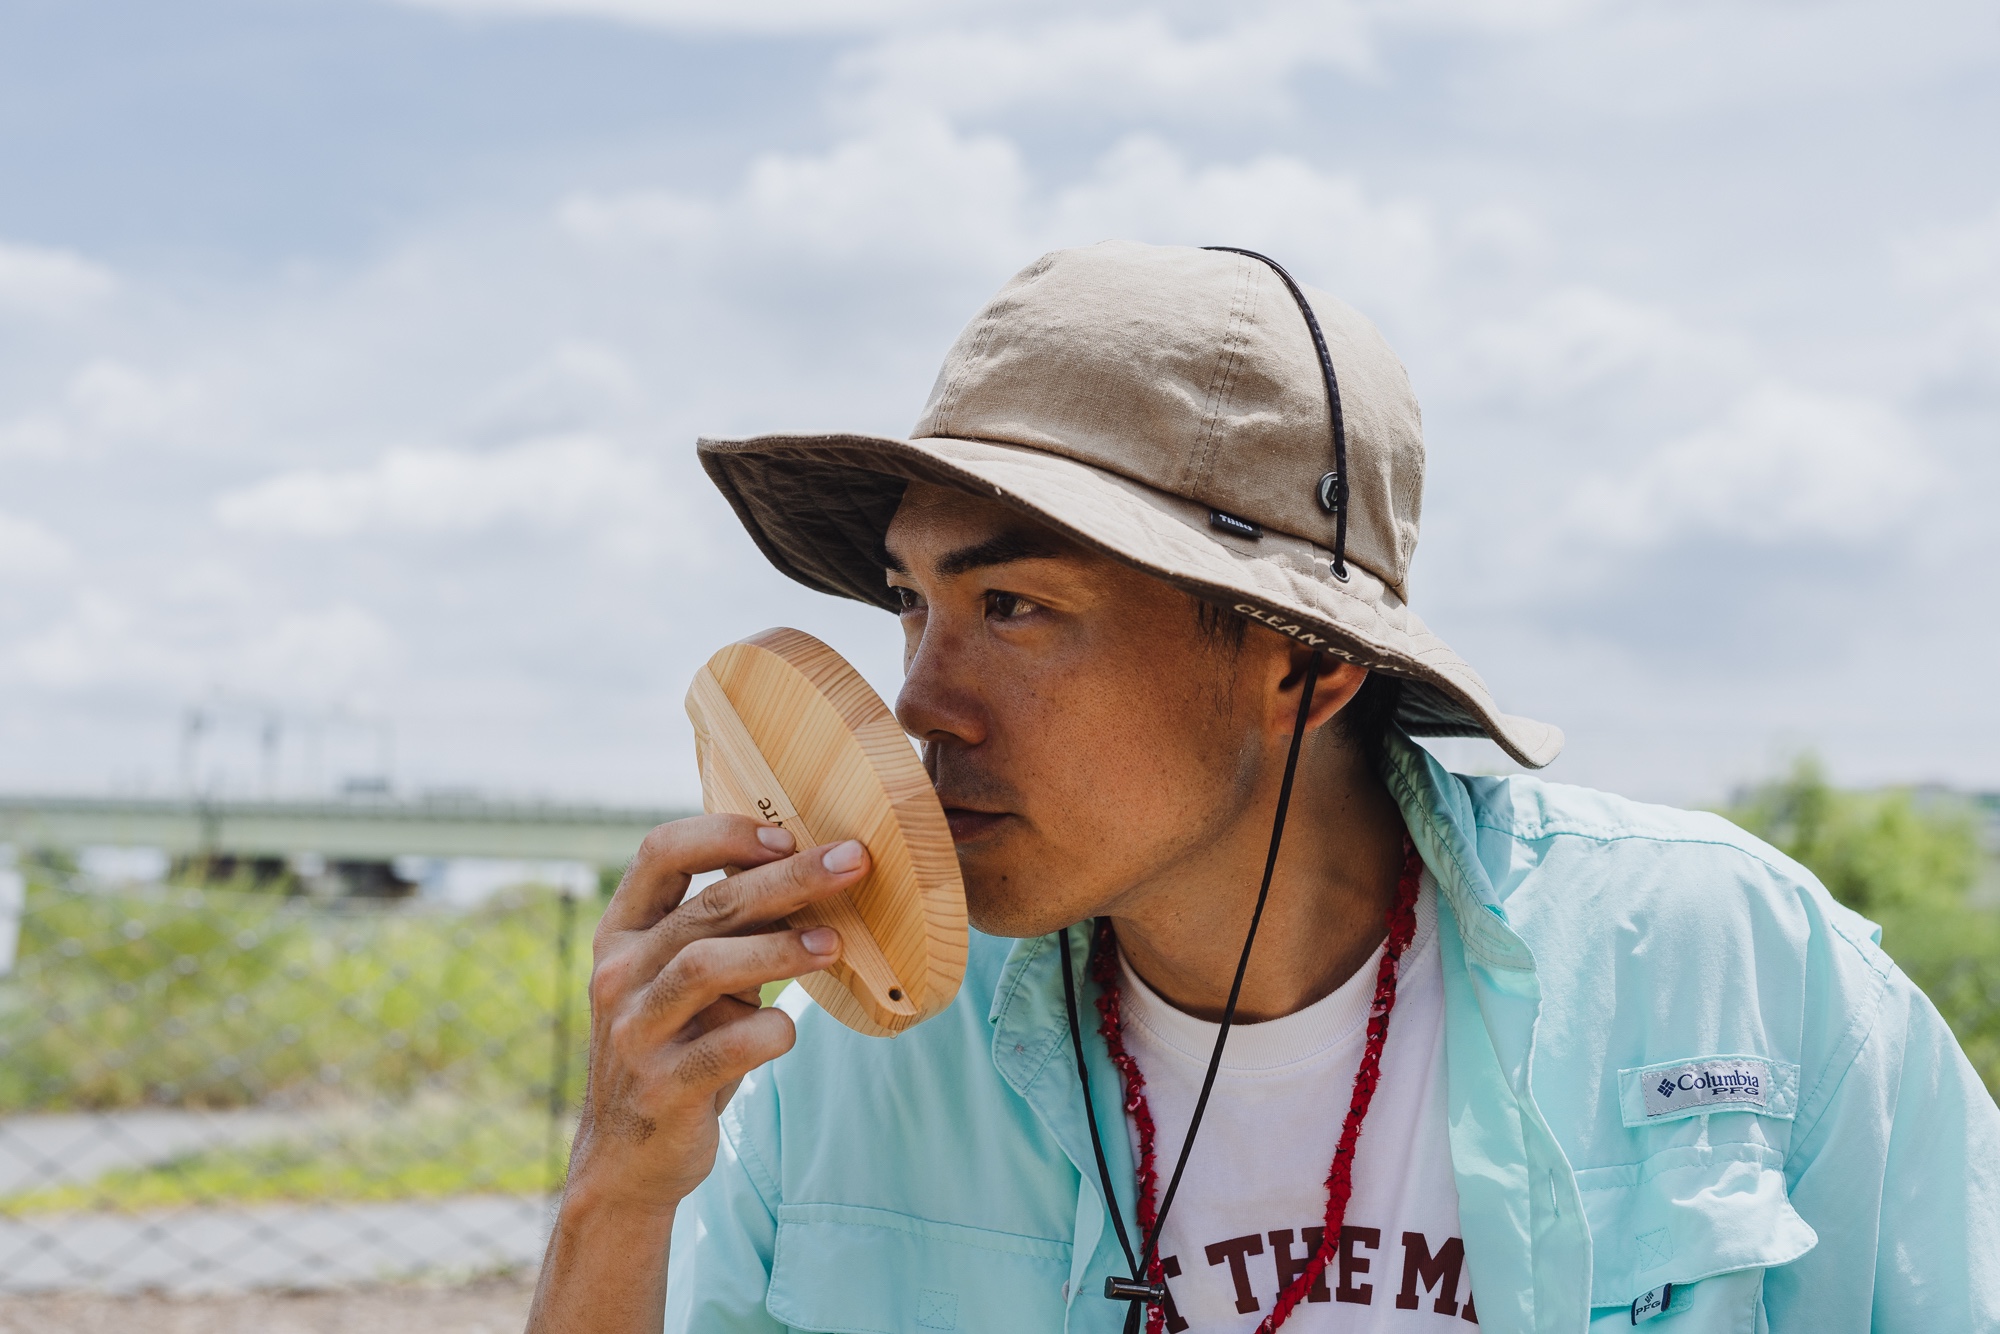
[0,0,2000,804]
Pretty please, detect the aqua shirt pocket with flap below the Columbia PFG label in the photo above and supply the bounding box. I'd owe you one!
[1576,1142,1820,1332]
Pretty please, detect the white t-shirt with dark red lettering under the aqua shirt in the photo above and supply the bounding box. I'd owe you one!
[1120,872,1478,1334]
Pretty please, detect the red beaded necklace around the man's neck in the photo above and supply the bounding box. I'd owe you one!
[1090,834,1424,1334]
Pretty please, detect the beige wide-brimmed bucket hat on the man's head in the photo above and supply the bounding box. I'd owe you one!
[698,240,1562,768]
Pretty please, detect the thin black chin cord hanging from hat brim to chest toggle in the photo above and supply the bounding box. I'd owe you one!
[1056,652,1324,1334]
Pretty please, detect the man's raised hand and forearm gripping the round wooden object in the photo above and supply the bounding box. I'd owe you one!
[528,816,868,1332]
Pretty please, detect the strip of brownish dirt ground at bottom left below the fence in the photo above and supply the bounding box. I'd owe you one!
[0,1276,534,1334]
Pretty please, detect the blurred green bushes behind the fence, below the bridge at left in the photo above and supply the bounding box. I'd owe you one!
[0,876,600,1112]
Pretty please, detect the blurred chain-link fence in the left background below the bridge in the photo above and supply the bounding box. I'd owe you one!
[0,866,598,1294]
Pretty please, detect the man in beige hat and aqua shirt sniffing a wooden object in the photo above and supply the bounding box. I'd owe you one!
[530,242,2000,1334]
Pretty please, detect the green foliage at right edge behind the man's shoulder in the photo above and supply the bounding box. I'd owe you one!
[1722,756,2000,1094]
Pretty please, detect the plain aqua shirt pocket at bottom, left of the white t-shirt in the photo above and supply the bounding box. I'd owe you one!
[764,1204,1070,1334]
